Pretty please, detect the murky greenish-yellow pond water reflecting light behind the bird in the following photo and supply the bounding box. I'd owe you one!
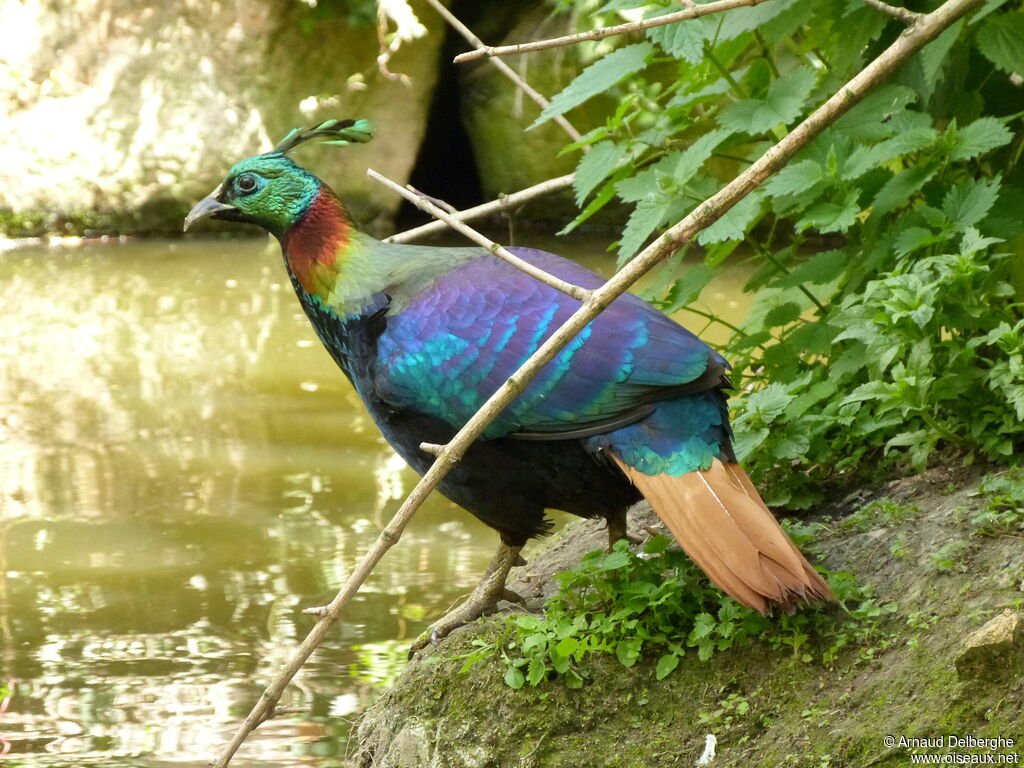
[0,237,745,768]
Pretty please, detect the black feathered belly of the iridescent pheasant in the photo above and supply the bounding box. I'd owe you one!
[370,407,640,547]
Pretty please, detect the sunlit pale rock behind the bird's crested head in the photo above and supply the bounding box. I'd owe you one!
[0,0,444,236]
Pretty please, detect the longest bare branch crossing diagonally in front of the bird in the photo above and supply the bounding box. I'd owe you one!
[207,0,983,768]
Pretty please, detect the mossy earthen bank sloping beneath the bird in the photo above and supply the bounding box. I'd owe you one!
[356,472,1024,768]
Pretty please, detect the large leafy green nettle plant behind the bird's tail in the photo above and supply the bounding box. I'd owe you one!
[535,0,1024,508]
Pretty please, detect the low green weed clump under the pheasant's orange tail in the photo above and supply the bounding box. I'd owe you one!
[463,537,895,688]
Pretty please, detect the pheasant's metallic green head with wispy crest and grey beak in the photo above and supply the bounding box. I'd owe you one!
[184,120,373,237]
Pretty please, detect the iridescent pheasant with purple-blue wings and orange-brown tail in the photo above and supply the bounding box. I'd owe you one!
[185,120,831,642]
